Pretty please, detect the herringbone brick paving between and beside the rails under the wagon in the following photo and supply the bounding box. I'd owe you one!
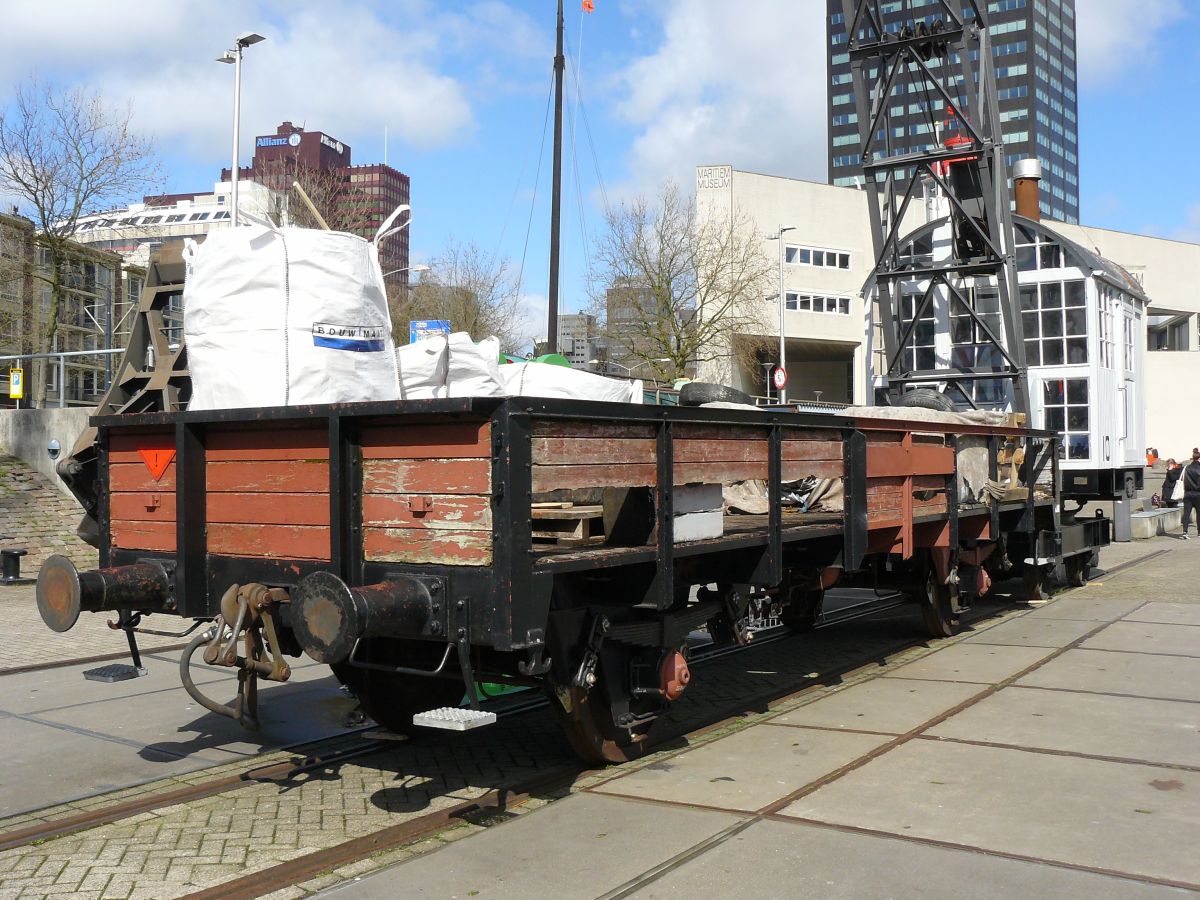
[0,545,1176,899]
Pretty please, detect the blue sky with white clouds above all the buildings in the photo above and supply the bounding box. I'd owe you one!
[0,0,1200,334]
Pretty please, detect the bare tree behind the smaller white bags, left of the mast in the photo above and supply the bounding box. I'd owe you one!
[391,239,521,348]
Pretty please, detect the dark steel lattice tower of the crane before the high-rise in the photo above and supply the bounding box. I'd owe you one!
[841,0,1028,413]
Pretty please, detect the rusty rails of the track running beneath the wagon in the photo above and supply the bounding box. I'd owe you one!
[0,550,1166,898]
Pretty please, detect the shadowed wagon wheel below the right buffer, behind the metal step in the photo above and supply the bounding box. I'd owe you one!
[330,640,464,734]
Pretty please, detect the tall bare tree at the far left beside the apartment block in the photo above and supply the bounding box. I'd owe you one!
[0,77,158,406]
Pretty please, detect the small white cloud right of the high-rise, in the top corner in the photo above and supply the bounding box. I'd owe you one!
[1075,0,1189,88]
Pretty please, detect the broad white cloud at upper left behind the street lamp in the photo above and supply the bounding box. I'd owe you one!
[0,0,539,160]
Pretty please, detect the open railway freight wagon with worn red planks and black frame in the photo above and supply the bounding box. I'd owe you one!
[37,397,1108,761]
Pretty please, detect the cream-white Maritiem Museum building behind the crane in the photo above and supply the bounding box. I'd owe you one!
[696,166,1200,458]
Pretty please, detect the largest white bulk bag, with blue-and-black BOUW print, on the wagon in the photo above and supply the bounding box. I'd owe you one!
[184,220,400,409]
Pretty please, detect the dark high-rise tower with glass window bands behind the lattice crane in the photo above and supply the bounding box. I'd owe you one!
[826,0,1079,223]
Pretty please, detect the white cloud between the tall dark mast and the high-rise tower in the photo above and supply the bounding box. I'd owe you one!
[619,0,828,199]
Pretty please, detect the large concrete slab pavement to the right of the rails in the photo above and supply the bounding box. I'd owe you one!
[321,538,1200,900]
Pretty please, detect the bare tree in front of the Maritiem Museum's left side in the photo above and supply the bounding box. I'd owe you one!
[593,181,773,380]
